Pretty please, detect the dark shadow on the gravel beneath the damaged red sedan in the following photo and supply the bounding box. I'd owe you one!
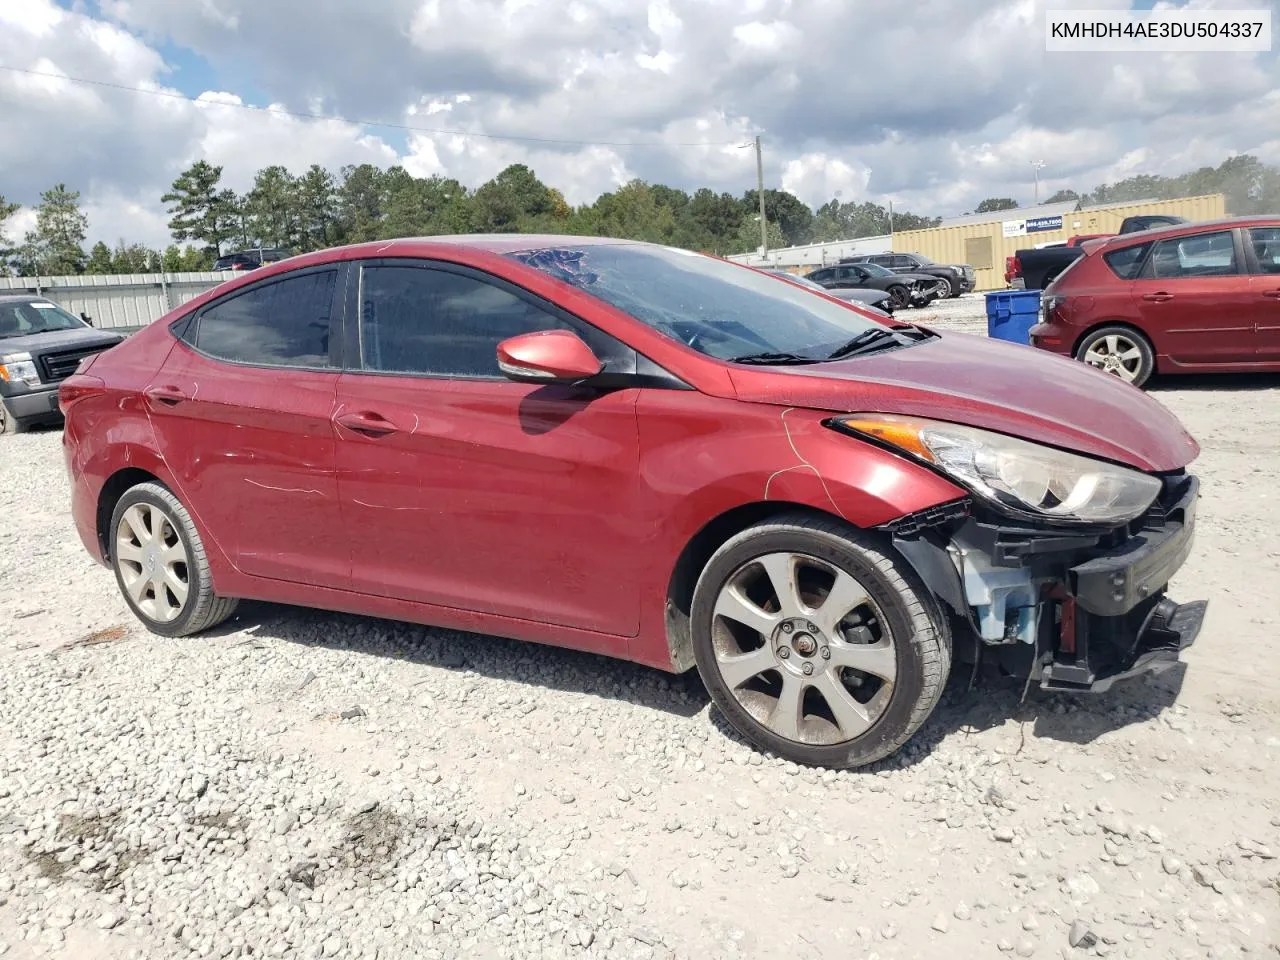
[212,603,1185,773]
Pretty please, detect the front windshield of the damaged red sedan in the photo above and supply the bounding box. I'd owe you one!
[508,243,884,360]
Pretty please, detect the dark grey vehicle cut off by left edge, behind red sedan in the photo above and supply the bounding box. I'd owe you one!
[0,293,124,434]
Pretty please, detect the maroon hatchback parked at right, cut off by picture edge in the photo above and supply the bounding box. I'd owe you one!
[1030,216,1280,385]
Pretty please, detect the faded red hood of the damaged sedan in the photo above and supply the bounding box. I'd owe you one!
[732,333,1199,471]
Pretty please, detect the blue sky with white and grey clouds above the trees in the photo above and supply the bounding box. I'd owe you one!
[0,0,1280,246]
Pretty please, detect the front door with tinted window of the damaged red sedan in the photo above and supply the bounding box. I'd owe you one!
[334,260,646,649]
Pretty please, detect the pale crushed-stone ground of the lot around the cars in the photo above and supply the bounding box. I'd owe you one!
[0,309,1280,960]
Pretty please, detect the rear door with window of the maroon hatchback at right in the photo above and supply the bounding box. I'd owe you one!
[1130,229,1257,364]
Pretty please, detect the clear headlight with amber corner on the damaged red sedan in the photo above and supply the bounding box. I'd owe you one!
[836,415,1161,526]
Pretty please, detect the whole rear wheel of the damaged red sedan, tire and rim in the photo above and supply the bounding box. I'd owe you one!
[109,483,239,636]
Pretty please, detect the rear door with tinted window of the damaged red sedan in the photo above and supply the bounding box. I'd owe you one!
[145,265,351,588]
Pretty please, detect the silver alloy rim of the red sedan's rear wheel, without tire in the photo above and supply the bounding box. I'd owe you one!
[114,503,191,623]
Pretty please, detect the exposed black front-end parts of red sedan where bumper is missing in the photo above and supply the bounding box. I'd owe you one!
[886,471,1207,692]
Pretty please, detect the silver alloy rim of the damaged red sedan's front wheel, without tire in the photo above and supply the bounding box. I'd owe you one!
[712,553,897,745]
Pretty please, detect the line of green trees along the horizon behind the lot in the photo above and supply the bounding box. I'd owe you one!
[0,154,1280,276]
